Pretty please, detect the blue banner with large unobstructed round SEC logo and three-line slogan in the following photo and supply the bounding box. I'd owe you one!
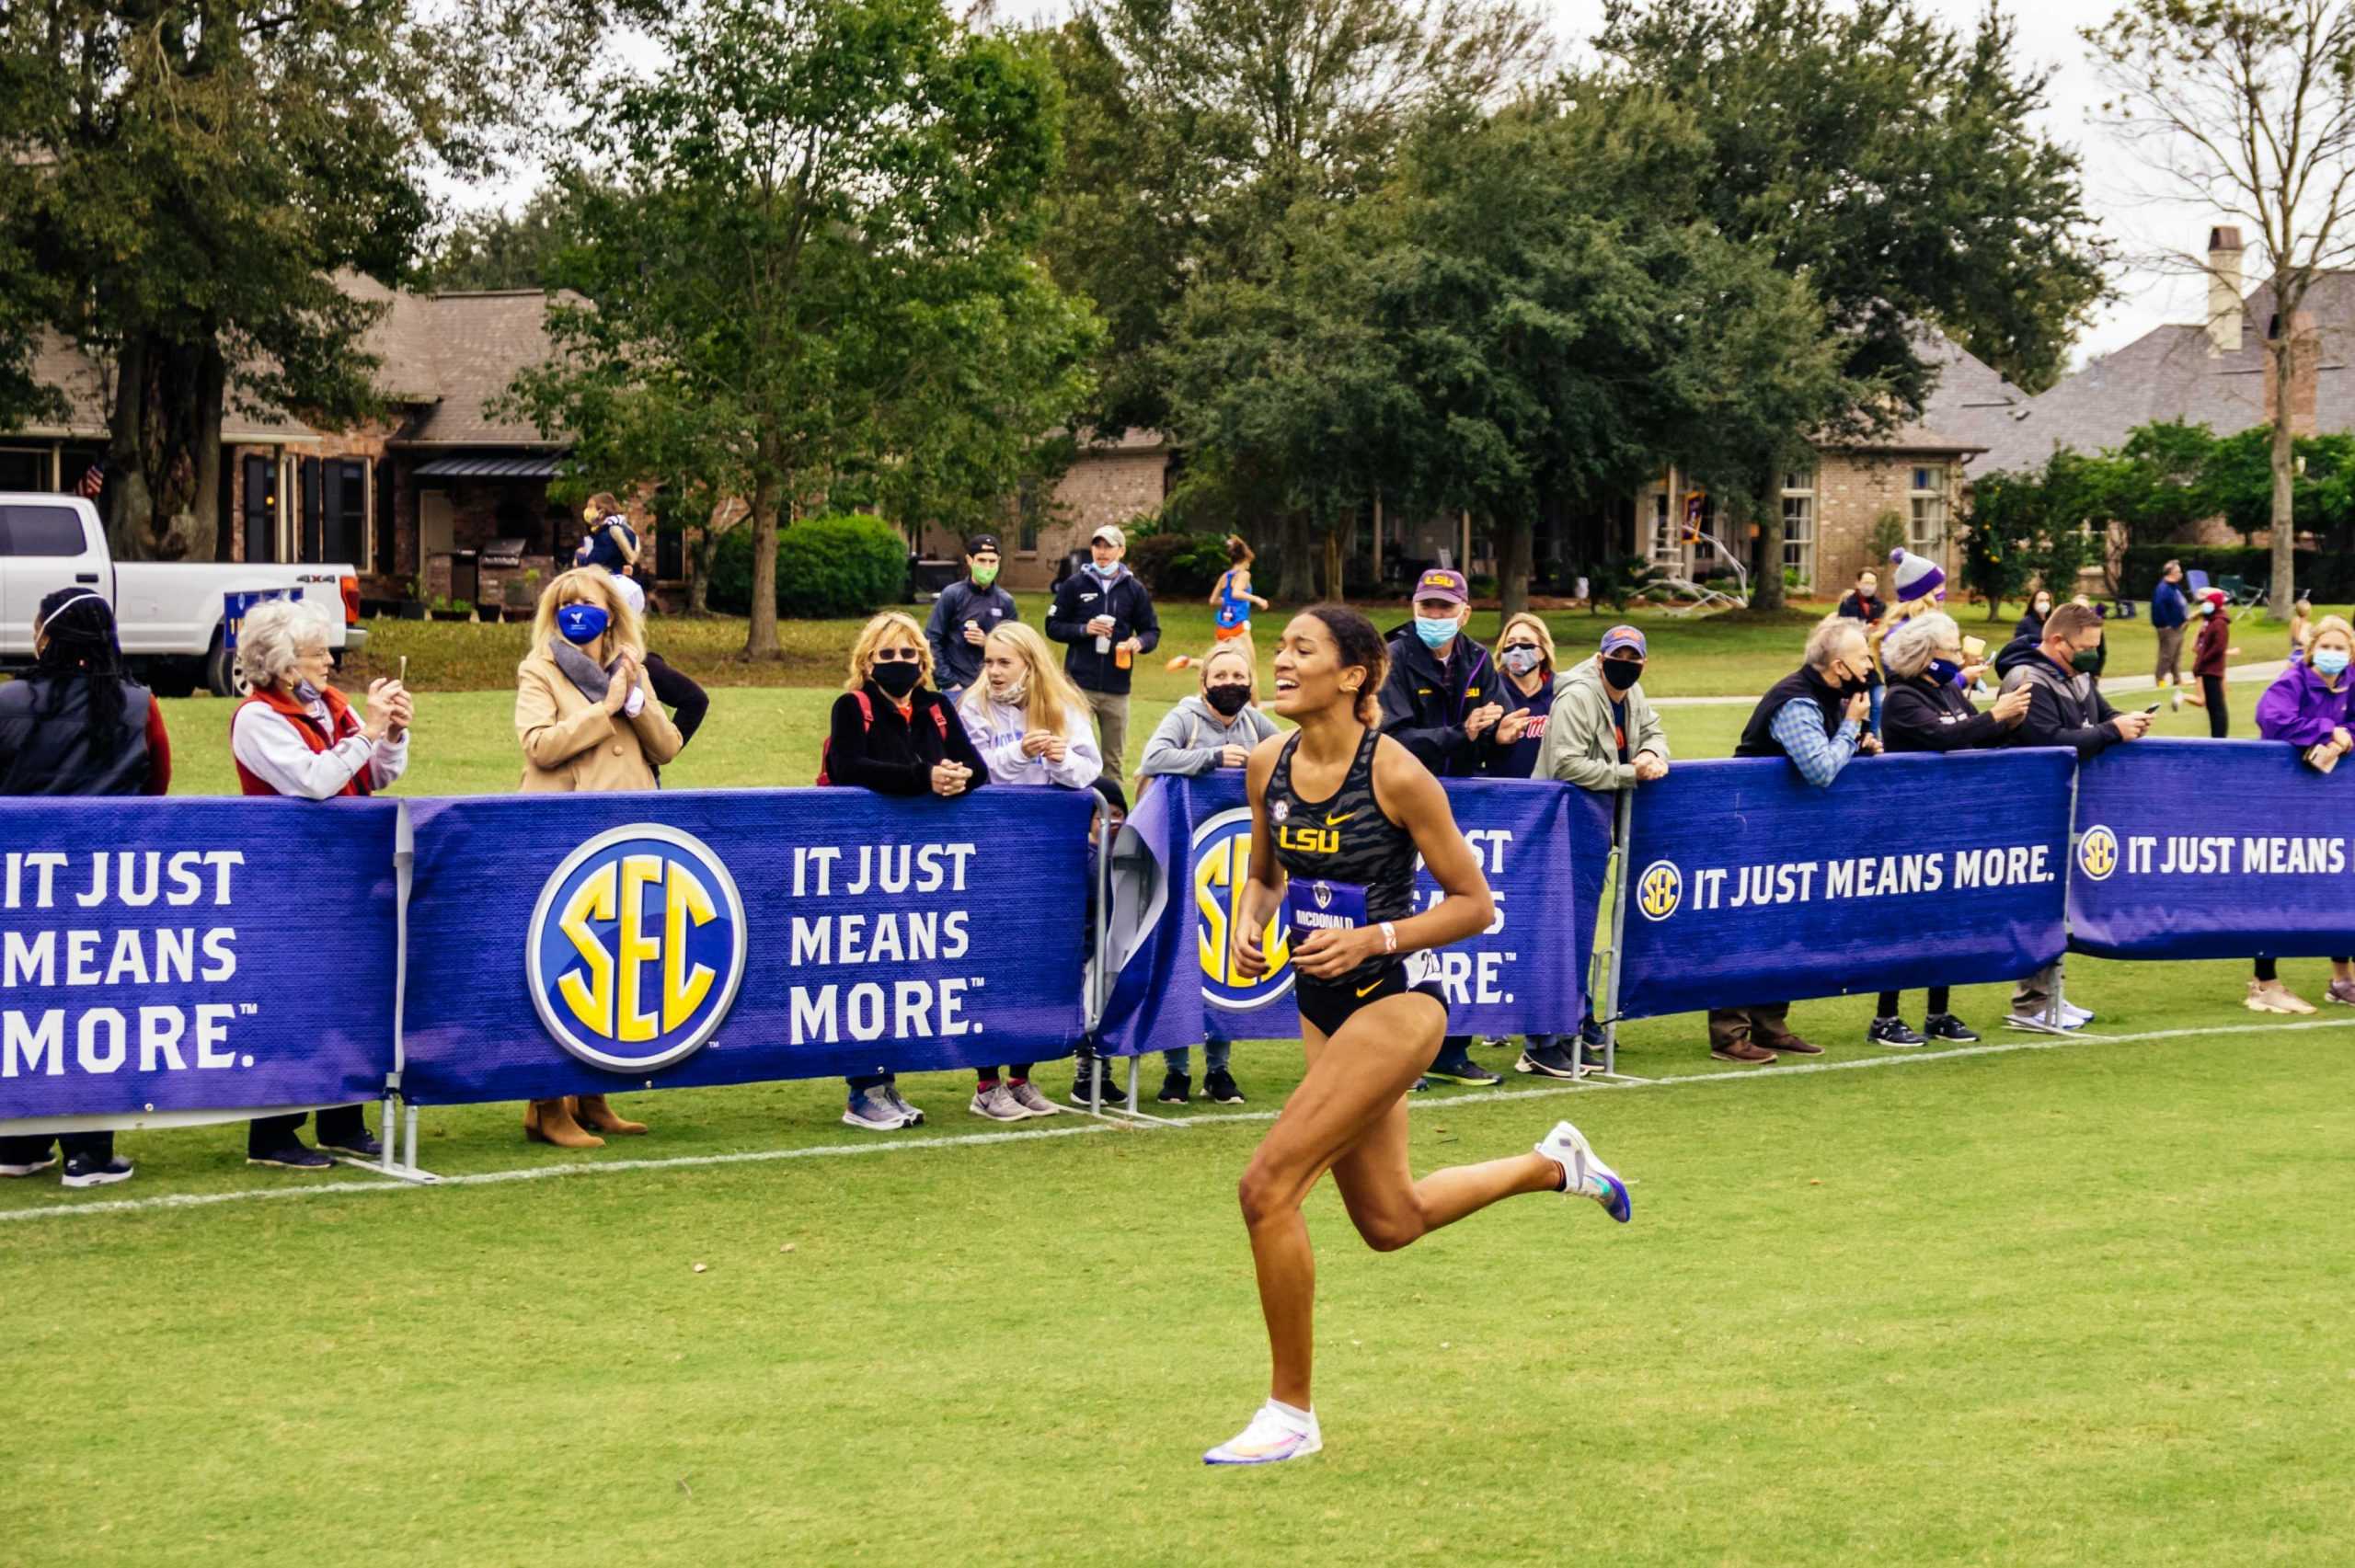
[403,786,1095,1104]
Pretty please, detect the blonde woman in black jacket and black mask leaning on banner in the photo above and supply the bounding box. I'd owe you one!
[817,610,989,1132]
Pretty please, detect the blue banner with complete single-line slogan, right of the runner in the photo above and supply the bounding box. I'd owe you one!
[1620,749,2074,1017]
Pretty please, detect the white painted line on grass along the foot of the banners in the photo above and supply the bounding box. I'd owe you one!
[0,1017,2355,1222]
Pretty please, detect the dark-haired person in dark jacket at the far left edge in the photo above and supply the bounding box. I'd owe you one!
[0,589,172,1186]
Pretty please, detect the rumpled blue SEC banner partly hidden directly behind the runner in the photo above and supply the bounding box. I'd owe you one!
[1097,768,1614,1055]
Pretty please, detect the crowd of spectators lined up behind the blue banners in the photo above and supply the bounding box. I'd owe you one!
[0,524,2355,1186]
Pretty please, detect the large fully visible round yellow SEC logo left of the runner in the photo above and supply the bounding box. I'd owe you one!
[530,821,744,1073]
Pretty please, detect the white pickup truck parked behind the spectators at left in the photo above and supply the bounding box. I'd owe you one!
[0,492,367,697]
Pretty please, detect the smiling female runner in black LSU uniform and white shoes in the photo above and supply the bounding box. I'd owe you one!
[1203,605,1630,1464]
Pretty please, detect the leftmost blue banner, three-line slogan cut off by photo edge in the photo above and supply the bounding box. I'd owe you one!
[0,795,400,1121]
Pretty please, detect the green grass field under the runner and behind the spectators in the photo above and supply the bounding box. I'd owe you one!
[0,593,2355,1568]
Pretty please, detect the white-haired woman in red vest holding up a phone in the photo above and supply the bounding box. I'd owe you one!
[228,601,415,1170]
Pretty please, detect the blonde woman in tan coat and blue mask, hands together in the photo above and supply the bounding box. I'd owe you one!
[516,567,685,1134]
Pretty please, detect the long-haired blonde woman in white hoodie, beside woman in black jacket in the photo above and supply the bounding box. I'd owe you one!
[956,622,1105,1121]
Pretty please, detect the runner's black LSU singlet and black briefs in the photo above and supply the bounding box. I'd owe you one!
[1267,730,1443,1034]
